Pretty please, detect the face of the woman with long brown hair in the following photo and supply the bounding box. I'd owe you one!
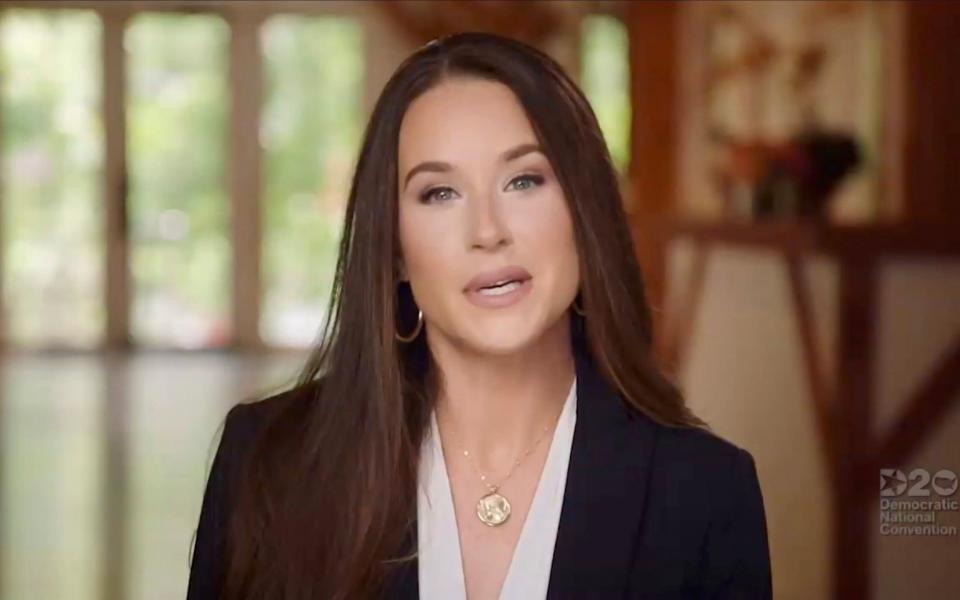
[398,77,580,353]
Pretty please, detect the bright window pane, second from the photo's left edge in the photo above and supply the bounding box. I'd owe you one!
[124,14,232,348]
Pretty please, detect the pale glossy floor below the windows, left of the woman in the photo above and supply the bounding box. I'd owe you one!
[0,352,303,600]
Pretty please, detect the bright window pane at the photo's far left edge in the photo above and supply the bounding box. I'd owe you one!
[0,10,106,347]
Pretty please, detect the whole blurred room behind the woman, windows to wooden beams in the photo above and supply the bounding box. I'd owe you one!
[0,0,960,600]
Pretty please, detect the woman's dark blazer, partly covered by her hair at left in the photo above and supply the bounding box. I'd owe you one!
[187,346,772,600]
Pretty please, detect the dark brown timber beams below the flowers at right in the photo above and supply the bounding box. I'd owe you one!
[652,221,960,599]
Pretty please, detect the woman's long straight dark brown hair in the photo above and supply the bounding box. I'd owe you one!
[225,33,702,599]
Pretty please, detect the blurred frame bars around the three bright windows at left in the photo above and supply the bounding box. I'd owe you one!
[0,0,374,354]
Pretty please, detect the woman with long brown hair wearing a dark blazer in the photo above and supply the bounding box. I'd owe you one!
[188,33,770,599]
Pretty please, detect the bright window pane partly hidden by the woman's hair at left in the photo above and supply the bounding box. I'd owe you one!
[260,15,364,347]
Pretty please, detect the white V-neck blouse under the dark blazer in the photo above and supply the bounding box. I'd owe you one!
[417,378,577,600]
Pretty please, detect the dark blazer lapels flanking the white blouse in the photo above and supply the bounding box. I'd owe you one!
[384,343,654,600]
